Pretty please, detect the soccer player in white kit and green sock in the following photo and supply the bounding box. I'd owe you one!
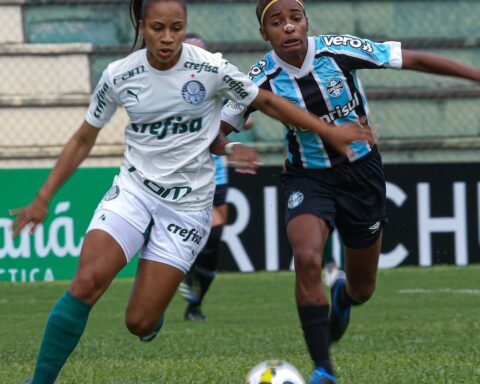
[11,0,371,384]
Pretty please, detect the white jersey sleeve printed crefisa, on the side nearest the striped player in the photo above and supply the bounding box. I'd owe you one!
[219,60,258,107]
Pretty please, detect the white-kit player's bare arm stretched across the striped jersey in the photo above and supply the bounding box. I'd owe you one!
[252,89,374,154]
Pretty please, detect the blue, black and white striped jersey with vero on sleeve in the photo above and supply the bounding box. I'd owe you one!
[222,35,402,169]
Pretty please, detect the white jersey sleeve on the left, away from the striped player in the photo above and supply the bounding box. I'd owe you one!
[85,69,118,128]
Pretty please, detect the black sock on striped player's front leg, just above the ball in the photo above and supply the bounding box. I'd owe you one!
[297,304,333,375]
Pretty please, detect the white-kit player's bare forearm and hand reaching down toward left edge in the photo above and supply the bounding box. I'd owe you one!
[9,121,100,237]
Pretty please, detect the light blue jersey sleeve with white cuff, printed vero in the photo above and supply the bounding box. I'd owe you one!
[319,35,402,70]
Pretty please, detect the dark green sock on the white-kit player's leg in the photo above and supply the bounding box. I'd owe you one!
[32,291,92,384]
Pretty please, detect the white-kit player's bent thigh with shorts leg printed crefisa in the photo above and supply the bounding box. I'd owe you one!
[127,204,212,323]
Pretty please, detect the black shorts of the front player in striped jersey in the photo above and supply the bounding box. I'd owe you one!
[281,147,386,249]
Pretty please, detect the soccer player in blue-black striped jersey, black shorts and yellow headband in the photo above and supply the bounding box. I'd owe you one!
[222,0,480,384]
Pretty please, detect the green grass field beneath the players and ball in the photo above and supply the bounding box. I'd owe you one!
[0,266,480,384]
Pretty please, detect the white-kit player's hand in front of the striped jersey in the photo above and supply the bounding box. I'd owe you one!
[324,122,377,156]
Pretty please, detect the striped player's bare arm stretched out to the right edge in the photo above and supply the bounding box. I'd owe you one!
[402,49,480,82]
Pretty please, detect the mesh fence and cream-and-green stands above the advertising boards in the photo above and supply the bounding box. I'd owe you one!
[0,0,480,167]
